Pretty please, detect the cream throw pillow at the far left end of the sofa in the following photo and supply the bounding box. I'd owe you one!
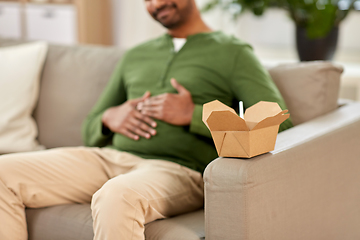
[0,42,47,154]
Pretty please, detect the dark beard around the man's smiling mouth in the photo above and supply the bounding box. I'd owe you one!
[151,1,191,29]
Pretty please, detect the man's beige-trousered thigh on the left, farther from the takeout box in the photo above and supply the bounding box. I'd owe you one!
[0,147,109,207]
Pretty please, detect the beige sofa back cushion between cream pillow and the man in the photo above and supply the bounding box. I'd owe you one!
[34,45,121,148]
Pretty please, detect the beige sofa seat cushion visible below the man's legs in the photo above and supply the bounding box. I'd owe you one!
[26,204,205,240]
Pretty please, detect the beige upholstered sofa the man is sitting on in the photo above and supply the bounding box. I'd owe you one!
[0,39,360,240]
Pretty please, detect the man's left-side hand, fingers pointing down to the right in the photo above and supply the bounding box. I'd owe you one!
[102,92,156,140]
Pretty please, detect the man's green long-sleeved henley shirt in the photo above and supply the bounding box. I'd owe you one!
[82,32,292,172]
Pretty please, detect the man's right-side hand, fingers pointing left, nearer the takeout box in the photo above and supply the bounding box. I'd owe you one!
[137,78,195,126]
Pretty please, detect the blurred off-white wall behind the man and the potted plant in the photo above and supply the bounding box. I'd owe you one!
[112,0,360,61]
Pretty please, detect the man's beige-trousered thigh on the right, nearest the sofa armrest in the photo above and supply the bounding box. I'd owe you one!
[95,159,204,223]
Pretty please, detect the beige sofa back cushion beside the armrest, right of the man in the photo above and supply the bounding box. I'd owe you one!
[269,61,343,125]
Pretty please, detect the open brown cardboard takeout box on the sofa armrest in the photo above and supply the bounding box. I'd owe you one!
[202,100,290,158]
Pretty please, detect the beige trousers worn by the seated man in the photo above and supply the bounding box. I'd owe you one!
[0,147,203,240]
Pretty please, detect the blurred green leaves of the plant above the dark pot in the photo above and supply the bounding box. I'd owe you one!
[203,0,359,39]
